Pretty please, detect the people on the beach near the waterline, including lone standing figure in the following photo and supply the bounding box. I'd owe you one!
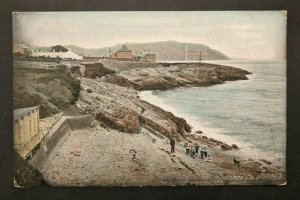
[170,138,213,162]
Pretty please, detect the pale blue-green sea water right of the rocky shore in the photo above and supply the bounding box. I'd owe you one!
[140,60,286,165]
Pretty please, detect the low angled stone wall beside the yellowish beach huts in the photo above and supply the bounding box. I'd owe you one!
[28,115,92,169]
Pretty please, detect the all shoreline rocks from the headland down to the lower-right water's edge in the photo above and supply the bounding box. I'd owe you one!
[67,62,285,184]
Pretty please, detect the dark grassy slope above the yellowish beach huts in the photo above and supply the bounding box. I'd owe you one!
[13,68,80,118]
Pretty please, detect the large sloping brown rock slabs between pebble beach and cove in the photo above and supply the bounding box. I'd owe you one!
[77,78,191,139]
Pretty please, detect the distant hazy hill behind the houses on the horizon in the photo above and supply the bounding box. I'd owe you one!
[63,41,230,61]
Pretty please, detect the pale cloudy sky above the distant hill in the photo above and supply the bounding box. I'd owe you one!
[13,11,287,59]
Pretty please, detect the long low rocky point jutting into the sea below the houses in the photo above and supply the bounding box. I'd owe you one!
[102,61,250,90]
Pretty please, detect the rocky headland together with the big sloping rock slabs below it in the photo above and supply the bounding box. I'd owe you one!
[75,62,250,140]
